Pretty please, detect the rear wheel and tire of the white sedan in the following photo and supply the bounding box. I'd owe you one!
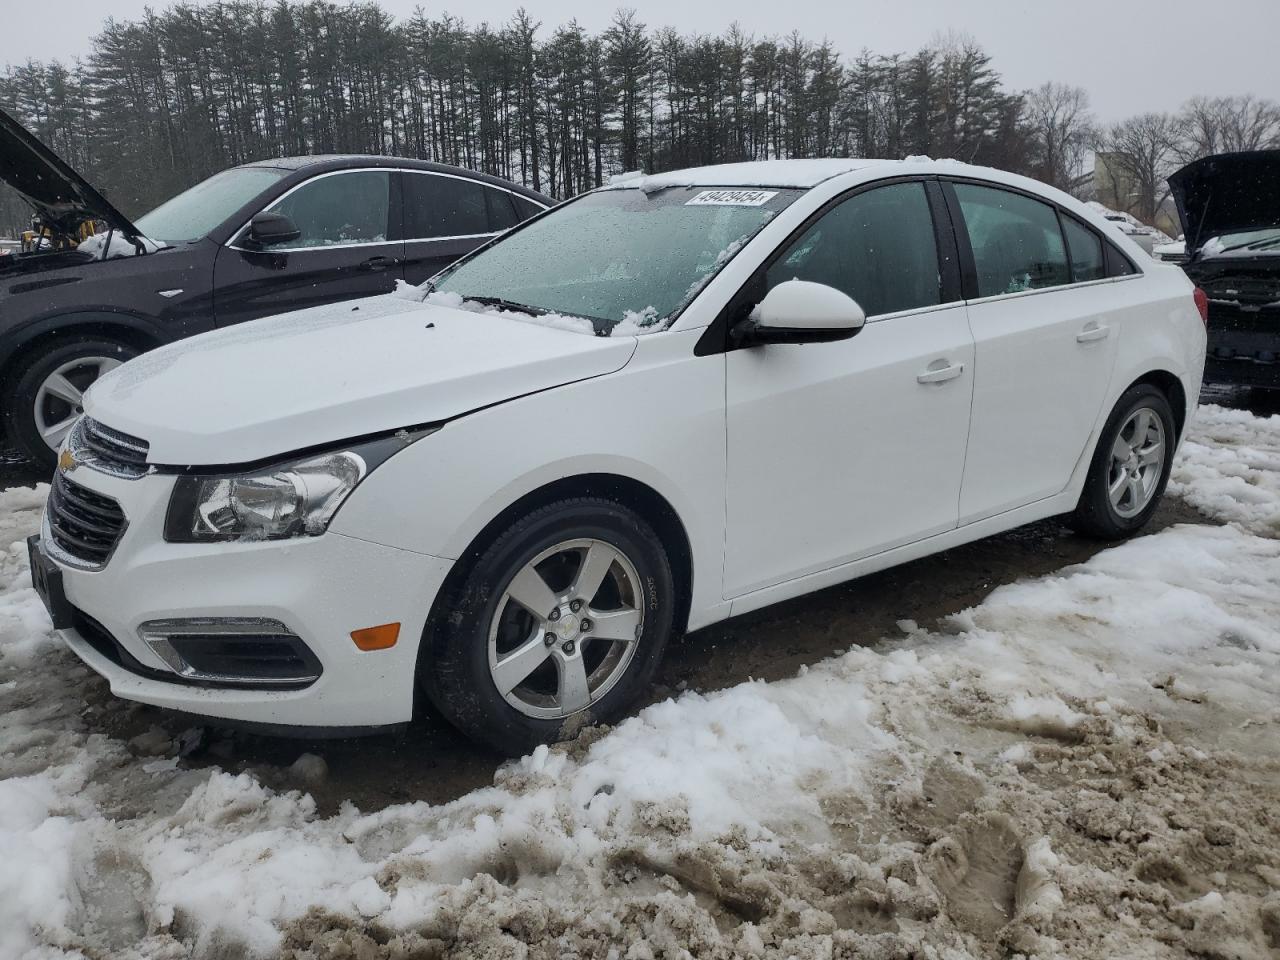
[1069,384,1178,540]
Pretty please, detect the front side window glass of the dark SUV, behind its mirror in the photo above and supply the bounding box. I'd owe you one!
[268,170,392,250]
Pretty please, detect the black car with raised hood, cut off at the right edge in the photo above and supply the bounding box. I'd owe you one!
[1169,150,1280,389]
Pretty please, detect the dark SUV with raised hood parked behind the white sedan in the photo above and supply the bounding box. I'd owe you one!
[0,104,553,466]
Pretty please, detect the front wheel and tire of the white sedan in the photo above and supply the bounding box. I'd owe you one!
[419,498,676,756]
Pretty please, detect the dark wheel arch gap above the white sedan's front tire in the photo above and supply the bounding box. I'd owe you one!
[419,472,694,657]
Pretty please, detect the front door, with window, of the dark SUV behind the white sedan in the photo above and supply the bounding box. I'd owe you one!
[214,169,404,326]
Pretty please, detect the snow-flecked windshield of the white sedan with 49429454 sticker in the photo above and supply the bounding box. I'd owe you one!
[434,187,800,334]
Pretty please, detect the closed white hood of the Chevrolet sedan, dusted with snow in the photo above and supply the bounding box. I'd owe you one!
[84,296,636,466]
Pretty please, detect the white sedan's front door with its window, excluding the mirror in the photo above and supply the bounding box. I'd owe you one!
[724,180,974,598]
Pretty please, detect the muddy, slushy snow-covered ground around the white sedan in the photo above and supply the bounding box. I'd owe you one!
[0,407,1280,960]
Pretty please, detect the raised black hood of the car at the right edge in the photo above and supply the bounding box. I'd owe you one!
[1169,150,1280,252]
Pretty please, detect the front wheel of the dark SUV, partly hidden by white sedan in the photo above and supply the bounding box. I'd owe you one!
[0,334,138,470]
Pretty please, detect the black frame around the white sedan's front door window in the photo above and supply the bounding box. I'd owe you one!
[694,174,965,357]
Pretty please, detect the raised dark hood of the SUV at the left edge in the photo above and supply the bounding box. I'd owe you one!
[0,110,141,244]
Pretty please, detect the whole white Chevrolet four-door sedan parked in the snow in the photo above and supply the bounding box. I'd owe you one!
[31,160,1204,753]
